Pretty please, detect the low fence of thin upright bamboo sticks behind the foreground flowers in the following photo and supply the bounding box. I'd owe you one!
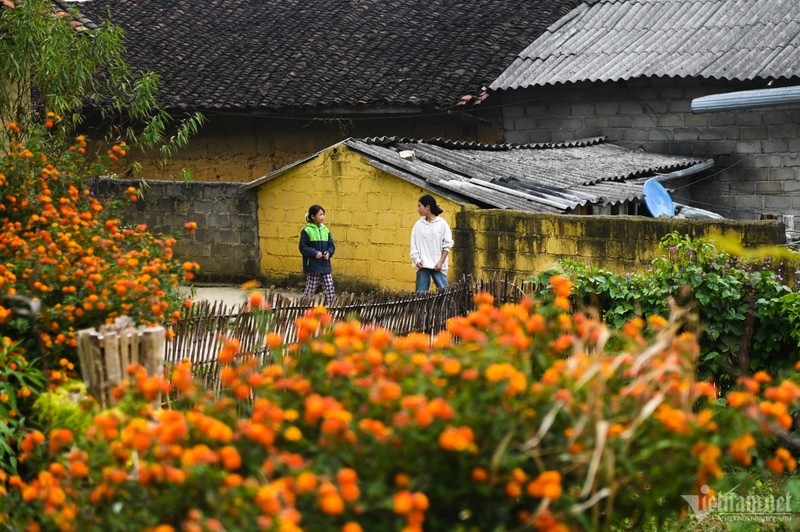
[164,277,533,387]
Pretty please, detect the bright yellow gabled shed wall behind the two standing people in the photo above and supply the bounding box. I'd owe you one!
[258,144,461,291]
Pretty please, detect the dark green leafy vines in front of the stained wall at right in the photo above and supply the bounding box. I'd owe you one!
[564,233,800,385]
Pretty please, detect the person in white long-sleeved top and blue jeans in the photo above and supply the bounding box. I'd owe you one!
[411,194,453,292]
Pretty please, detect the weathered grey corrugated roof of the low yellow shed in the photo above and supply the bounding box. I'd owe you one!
[244,137,701,213]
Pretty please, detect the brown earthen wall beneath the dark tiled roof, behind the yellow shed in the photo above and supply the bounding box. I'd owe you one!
[133,108,503,183]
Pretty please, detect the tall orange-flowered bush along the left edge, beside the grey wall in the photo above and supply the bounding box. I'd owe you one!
[0,120,198,471]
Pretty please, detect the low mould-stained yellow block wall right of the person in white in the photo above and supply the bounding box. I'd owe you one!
[453,209,784,279]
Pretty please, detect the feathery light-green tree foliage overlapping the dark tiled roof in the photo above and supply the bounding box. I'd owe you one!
[0,0,205,179]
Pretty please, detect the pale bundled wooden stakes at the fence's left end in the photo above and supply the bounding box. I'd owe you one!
[77,319,165,408]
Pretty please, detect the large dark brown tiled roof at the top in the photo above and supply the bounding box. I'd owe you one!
[80,0,580,111]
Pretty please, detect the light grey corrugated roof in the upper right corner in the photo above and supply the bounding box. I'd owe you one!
[490,0,800,90]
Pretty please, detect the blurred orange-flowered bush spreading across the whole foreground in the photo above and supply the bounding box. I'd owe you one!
[0,276,800,531]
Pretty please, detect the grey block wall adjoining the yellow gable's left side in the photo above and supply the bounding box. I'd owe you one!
[92,179,259,283]
